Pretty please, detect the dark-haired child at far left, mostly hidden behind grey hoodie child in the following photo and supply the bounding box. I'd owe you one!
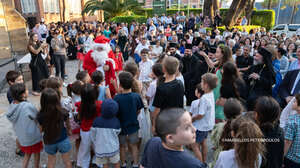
[6,70,24,157]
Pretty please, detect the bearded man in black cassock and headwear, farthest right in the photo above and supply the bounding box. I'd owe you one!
[243,48,275,111]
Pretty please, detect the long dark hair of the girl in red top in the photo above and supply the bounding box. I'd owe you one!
[79,83,99,120]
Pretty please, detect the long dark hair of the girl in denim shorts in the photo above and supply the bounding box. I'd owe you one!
[37,88,64,144]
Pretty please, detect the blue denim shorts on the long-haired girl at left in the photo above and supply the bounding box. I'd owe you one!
[45,138,71,155]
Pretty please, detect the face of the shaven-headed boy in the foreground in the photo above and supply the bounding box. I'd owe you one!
[172,112,196,145]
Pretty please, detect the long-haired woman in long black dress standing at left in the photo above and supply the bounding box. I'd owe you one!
[27,33,49,96]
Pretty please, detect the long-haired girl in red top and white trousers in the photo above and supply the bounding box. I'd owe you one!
[75,83,102,168]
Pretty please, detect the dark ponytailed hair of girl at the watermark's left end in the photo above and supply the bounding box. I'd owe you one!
[219,98,243,150]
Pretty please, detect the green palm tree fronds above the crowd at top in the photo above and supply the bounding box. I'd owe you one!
[82,0,145,19]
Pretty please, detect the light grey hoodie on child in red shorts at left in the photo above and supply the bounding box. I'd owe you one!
[6,101,42,146]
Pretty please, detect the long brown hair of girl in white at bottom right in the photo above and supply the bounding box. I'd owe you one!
[231,115,265,168]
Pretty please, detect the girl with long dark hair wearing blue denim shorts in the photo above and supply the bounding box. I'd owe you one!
[37,88,72,168]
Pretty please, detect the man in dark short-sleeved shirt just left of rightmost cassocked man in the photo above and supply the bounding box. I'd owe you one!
[236,45,254,72]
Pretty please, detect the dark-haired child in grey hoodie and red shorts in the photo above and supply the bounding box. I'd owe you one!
[6,83,43,168]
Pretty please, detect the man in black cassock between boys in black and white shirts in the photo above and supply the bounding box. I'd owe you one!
[181,44,199,106]
